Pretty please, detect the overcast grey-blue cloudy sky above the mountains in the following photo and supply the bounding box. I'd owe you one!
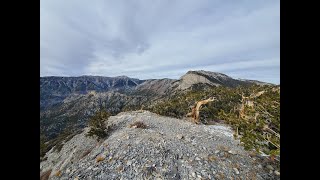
[40,0,280,84]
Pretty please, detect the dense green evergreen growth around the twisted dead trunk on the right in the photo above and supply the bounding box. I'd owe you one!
[149,85,280,155]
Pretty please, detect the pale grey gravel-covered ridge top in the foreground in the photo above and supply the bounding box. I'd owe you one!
[40,111,280,180]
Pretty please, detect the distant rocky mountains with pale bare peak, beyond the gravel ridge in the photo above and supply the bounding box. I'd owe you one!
[40,70,272,139]
